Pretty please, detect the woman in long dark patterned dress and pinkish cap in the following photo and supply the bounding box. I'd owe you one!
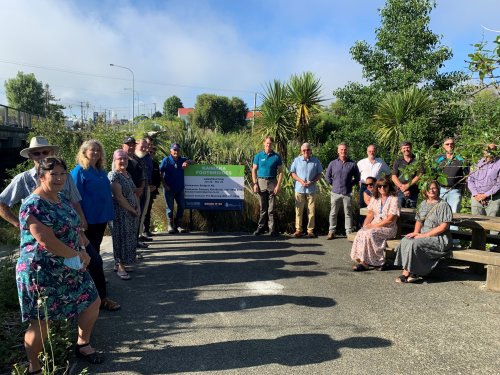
[108,150,141,280]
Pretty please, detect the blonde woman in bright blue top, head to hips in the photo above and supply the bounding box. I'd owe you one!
[71,139,114,253]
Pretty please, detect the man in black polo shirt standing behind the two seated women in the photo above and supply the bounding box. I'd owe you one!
[391,141,421,208]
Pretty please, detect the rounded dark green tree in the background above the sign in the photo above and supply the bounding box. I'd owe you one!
[191,94,248,133]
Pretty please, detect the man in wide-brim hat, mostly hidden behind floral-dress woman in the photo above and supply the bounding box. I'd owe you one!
[0,137,87,227]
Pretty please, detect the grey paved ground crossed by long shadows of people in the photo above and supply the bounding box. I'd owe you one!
[71,233,500,375]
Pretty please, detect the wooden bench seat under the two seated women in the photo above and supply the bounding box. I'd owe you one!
[347,232,500,292]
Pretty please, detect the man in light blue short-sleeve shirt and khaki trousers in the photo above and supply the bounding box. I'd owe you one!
[290,143,323,238]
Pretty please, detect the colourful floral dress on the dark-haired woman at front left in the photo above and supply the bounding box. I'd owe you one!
[16,194,97,321]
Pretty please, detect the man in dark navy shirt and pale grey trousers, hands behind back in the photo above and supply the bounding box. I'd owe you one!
[326,143,360,240]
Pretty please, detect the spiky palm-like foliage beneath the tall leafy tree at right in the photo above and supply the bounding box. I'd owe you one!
[372,86,432,155]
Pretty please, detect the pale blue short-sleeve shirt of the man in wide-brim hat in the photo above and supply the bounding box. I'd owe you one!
[0,168,82,207]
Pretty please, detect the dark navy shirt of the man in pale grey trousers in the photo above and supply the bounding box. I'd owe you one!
[326,158,359,195]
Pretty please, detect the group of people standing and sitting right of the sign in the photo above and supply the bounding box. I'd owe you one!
[252,137,500,283]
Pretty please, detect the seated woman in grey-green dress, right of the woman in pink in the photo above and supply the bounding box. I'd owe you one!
[394,181,453,283]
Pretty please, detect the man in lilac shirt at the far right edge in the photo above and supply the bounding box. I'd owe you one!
[467,144,500,220]
